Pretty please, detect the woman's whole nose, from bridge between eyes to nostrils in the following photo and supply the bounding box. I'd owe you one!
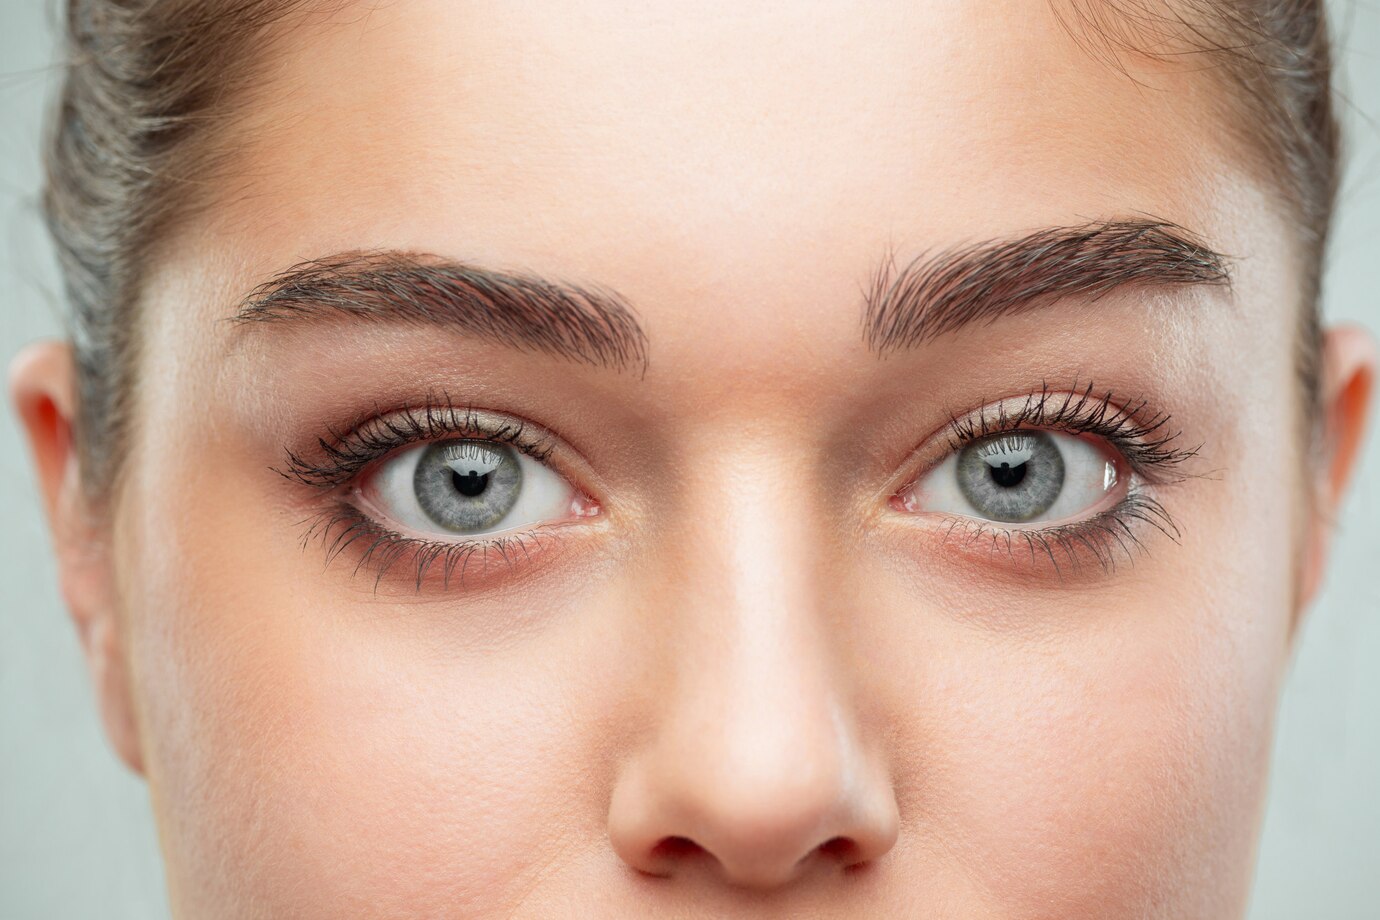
[609,468,898,888]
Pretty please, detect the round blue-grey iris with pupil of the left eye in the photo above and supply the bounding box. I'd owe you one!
[413,440,522,534]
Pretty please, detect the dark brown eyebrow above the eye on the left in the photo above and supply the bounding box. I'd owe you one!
[233,250,647,374]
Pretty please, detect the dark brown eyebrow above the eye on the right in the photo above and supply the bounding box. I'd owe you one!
[863,218,1231,354]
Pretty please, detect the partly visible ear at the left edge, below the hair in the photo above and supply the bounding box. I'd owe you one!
[10,341,144,774]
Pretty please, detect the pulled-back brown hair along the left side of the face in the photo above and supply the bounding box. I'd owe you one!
[43,0,313,497]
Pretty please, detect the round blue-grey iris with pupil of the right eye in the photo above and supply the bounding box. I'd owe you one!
[958,430,1064,523]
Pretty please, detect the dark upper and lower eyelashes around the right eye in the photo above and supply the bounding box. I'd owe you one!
[907,383,1201,578]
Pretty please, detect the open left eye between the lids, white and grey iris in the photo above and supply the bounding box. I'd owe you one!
[359,439,578,537]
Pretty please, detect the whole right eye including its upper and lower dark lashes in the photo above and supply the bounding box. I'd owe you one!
[891,383,1199,577]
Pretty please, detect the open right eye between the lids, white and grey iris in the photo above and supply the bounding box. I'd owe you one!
[898,429,1123,524]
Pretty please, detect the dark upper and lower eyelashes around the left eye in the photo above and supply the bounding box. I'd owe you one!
[275,393,579,592]
